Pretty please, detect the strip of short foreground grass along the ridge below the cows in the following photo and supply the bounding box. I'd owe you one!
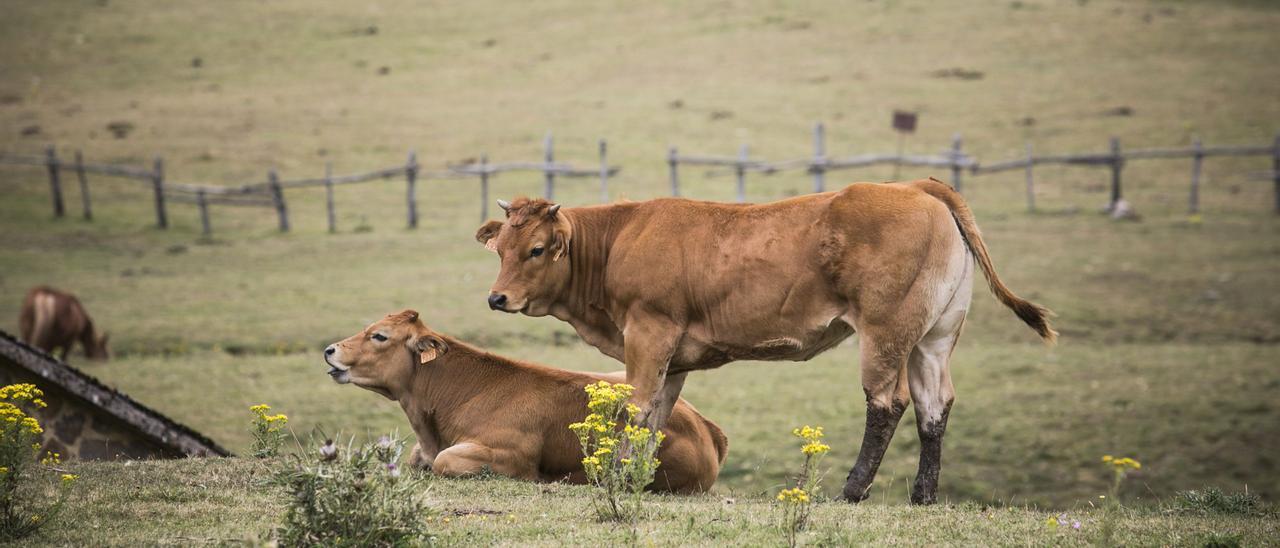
[22,458,1280,545]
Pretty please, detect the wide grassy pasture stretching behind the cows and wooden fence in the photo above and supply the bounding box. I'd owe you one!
[0,0,1280,543]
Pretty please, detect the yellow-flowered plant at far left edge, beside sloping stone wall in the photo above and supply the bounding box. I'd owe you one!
[0,384,78,542]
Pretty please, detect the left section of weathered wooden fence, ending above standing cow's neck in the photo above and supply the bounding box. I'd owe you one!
[0,134,621,237]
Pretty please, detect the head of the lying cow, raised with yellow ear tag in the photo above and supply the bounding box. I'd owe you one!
[324,310,449,399]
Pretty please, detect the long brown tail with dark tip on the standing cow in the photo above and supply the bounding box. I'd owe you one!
[915,177,1057,344]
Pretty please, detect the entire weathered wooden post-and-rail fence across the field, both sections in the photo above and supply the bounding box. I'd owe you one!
[0,123,1280,237]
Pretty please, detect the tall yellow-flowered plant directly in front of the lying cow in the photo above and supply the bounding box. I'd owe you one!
[568,380,666,524]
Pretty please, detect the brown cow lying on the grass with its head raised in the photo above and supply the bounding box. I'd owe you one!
[324,310,728,493]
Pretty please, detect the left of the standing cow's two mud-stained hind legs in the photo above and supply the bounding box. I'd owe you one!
[844,329,916,502]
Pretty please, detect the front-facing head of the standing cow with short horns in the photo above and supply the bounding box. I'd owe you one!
[476,198,573,316]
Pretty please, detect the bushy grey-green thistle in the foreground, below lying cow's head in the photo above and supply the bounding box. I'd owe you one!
[273,437,430,547]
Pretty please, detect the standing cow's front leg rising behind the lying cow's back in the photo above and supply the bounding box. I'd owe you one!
[623,321,685,431]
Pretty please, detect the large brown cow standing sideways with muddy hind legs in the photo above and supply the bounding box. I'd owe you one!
[476,179,1056,503]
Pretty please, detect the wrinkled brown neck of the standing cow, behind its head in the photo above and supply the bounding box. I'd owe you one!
[550,204,635,360]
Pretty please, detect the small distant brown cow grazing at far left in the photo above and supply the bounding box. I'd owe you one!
[18,286,110,361]
